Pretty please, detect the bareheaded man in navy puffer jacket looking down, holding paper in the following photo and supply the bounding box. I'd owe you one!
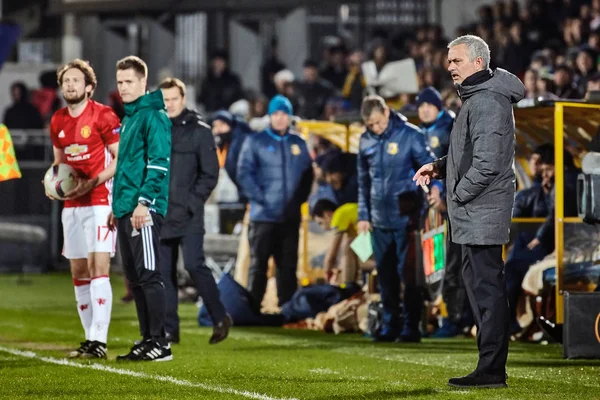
[358,96,434,342]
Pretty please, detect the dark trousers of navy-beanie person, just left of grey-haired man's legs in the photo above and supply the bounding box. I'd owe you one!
[442,240,466,324]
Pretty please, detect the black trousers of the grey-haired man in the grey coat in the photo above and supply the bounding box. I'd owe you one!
[462,245,509,376]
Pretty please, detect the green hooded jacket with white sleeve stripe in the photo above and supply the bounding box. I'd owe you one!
[112,90,171,218]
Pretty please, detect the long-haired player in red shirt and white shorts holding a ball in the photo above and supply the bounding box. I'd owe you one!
[49,59,121,358]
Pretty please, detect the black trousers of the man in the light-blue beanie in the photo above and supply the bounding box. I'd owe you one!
[248,222,300,309]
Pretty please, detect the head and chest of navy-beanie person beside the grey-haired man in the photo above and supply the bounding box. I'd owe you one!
[417,86,454,158]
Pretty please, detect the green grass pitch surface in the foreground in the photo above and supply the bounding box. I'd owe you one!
[0,274,600,400]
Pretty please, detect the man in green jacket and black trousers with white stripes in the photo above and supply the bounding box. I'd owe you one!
[108,56,173,361]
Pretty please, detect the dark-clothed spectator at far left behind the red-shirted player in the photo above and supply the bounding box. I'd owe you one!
[4,82,44,129]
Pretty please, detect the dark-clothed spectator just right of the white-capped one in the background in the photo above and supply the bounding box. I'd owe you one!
[296,60,335,119]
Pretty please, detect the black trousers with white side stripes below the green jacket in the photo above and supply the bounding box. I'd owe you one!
[117,212,166,345]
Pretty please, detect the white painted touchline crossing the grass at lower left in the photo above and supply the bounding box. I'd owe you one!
[0,346,298,400]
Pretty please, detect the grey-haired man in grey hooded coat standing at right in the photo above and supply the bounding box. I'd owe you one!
[414,35,525,388]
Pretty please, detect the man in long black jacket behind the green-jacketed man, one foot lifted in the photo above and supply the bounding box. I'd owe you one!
[159,78,232,344]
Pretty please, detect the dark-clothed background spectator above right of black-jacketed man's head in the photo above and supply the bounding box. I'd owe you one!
[198,50,244,112]
